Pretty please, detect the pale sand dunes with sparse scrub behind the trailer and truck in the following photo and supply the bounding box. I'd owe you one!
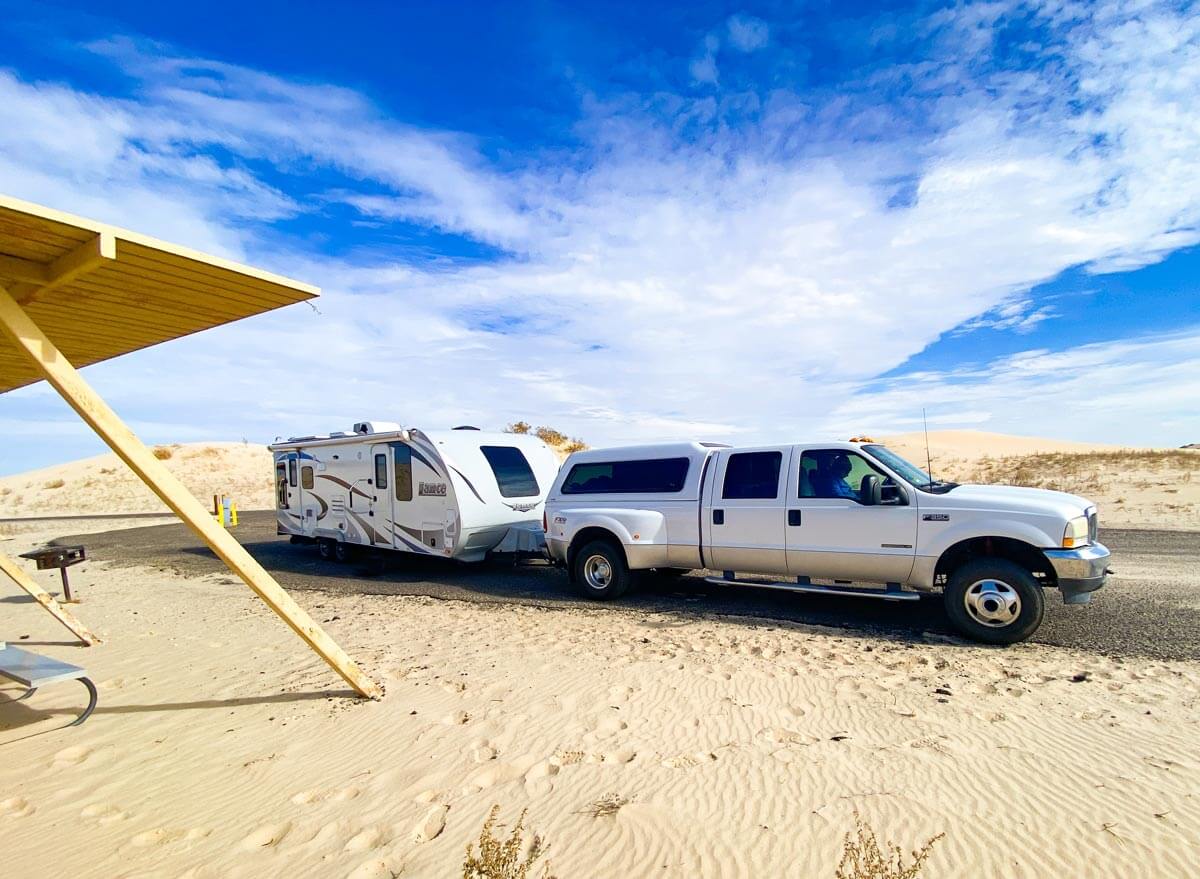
[0,430,1200,531]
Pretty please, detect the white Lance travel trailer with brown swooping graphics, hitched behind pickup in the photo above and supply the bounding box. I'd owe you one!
[270,421,559,562]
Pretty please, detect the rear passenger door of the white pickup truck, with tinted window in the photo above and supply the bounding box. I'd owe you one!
[704,447,792,574]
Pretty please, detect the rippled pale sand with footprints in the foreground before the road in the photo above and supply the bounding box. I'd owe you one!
[7,525,1200,879]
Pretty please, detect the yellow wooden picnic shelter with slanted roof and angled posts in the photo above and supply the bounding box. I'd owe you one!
[0,196,383,699]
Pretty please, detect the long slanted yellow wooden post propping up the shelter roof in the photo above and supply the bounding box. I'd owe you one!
[0,288,383,699]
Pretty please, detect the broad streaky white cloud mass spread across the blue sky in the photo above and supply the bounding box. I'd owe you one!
[0,6,1200,466]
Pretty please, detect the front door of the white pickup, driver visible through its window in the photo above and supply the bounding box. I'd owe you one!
[787,447,918,582]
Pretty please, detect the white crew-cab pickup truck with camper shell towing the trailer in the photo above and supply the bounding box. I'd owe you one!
[545,442,1109,644]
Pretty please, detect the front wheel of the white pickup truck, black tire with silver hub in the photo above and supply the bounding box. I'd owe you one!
[943,558,1046,644]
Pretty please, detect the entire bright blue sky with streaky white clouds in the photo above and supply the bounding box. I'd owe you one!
[0,0,1200,472]
